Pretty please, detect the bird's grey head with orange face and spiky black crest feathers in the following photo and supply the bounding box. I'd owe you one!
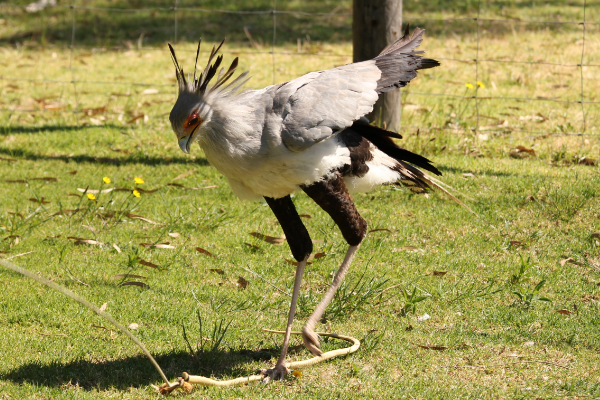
[169,41,248,153]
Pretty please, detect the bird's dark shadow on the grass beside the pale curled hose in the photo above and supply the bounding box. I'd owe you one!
[3,349,278,390]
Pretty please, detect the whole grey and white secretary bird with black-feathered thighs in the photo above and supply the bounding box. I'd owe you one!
[169,26,458,382]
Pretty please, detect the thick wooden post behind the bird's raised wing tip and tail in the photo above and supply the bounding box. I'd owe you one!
[352,0,402,131]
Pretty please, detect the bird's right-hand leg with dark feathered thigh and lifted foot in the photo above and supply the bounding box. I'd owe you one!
[302,173,367,355]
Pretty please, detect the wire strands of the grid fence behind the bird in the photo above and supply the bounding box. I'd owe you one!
[0,0,600,136]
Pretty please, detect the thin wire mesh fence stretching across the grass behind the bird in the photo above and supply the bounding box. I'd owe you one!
[0,0,600,136]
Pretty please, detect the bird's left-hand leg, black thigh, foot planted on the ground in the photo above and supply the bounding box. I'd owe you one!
[261,196,312,382]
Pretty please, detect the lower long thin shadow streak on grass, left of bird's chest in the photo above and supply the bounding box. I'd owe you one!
[0,148,209,166]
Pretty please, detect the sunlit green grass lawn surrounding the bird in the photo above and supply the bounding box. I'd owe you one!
[0,2,600,399]
